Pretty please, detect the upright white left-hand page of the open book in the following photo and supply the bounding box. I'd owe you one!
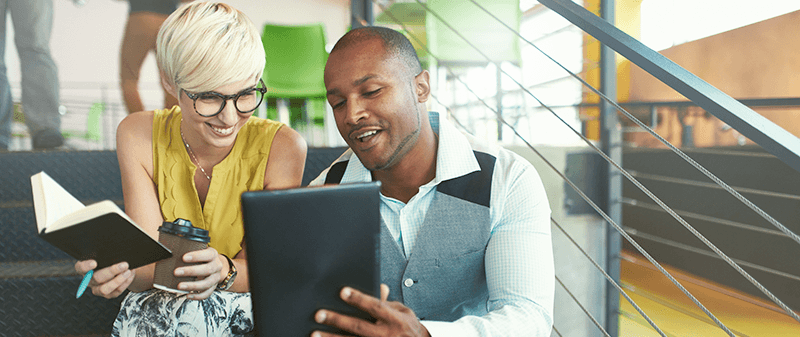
[31,171,84,233]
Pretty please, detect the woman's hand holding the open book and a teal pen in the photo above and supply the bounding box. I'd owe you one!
[75,260,136,298]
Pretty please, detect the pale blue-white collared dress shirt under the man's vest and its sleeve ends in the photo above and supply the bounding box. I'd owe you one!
[311,112,555,337]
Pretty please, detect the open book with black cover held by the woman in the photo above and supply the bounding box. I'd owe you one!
[31,171,172,269]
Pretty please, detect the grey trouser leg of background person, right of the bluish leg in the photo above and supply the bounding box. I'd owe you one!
[8,0,64,149]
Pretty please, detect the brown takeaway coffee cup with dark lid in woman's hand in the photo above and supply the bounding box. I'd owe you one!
[153,219,211,294]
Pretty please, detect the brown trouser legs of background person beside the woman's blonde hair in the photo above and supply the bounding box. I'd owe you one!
[119,12,169,114]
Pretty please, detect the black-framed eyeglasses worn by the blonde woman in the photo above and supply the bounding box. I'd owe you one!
[181,79,267,117]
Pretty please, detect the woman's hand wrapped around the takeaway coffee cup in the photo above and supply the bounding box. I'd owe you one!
[175,247,228,300]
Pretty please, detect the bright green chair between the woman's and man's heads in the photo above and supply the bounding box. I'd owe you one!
[261,24,328,129]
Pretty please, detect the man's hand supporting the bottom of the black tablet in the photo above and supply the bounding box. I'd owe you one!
[311,284,430,337]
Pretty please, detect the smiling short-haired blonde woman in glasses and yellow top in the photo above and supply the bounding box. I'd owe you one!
[75,2,306,336]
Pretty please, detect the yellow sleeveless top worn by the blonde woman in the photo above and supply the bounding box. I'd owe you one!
[153,106,283,257]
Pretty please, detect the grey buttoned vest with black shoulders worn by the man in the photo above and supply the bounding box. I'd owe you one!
[325,151,495,322]
